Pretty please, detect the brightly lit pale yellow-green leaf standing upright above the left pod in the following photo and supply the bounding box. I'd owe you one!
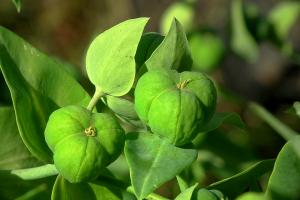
[86,18,148,96]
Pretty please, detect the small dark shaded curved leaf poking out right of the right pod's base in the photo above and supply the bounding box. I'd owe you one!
[199,112,245,132]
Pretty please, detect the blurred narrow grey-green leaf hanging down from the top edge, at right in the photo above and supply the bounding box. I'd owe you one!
[231,0,259,62]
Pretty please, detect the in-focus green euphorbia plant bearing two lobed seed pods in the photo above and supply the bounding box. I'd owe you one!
[0,15,298,200]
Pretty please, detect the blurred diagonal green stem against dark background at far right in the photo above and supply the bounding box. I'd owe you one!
[249,102,298,140]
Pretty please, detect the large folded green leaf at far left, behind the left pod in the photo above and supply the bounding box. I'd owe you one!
[0,27,90,162]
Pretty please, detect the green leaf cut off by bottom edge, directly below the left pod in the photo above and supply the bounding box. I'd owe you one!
[51,176,134,200]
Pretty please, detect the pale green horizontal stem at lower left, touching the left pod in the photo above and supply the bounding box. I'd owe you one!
[11,164,58,180]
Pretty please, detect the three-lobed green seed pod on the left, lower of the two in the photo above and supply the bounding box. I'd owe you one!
[45,106,125,183]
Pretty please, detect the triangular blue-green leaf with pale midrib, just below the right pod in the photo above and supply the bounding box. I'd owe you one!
[124,133,197,199]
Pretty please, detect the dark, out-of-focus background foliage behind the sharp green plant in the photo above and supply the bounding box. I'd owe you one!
[0,0,300,196]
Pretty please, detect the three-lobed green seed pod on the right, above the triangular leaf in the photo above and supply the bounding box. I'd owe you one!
[135,70,216,146]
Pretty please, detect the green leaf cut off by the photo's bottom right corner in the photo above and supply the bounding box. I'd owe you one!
[267,136,300,200]
